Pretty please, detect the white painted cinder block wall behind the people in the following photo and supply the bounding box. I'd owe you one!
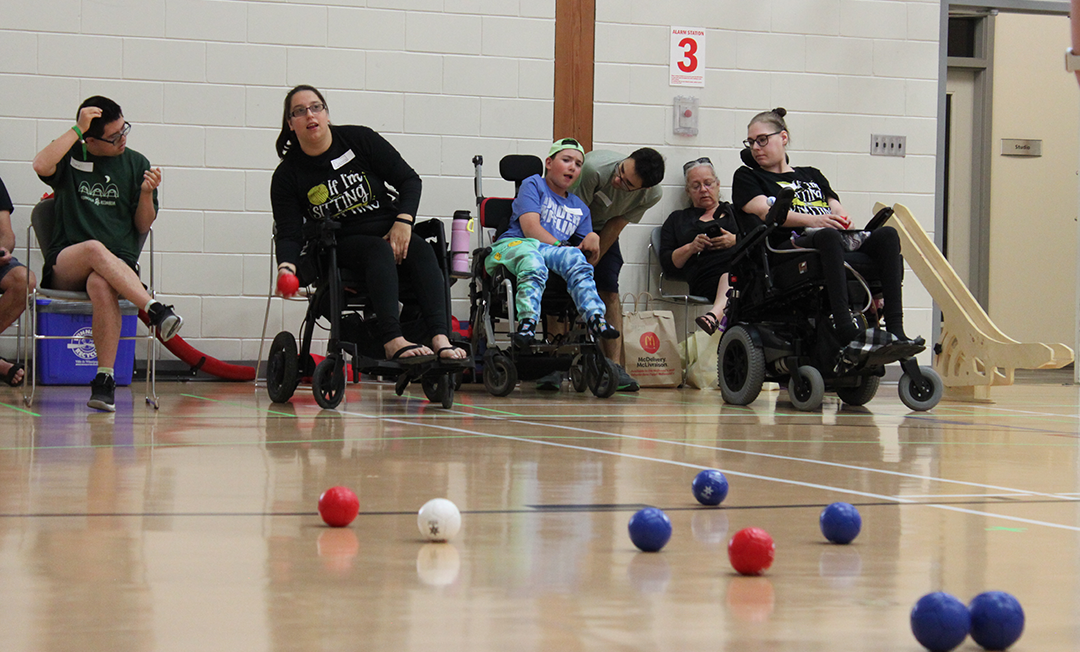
[0,0,939,361]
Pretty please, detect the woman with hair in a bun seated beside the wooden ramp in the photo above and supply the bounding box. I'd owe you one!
[731,108,924,352]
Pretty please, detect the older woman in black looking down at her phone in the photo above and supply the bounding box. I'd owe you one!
[660,158,738,335]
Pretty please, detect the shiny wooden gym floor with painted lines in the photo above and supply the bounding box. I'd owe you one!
[0,375,1080,652]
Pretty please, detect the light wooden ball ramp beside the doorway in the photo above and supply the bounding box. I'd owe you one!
[874,203,1074,400]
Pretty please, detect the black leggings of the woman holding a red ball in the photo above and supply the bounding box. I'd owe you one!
[338,234,449,344]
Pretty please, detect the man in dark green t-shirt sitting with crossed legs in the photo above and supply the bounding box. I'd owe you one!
[33,95,184,412]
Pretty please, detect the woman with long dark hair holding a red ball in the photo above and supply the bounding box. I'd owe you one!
[270,85,467,363]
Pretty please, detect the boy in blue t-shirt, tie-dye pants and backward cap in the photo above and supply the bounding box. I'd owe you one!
[485,138,619,345]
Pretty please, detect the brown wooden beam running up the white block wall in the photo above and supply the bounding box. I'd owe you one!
[552,0,596,151]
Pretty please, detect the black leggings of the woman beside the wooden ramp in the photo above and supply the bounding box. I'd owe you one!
[796,227,906,337]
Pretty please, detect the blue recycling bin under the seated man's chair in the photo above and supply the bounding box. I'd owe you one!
[35,298,138,385]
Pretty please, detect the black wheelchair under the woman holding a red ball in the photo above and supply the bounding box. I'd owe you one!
[267,214,472,409]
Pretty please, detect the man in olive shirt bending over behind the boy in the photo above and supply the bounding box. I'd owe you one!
[570,147,664,392]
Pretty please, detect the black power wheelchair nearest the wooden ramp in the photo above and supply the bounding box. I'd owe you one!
[717,188,944,411]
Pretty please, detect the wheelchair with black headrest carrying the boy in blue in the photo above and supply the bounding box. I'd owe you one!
[469,154,619,398]
